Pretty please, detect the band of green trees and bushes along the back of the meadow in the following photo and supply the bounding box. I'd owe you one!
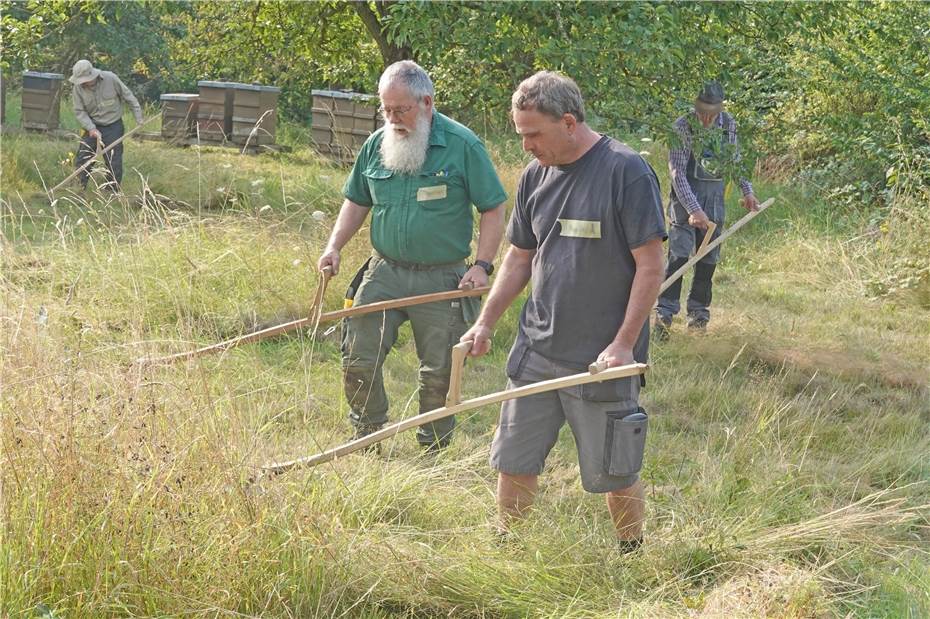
[2,0,930,198]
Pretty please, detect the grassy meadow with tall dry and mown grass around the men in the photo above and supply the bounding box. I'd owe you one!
[0,93,930,618]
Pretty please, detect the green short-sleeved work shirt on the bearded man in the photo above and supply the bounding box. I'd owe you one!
[342,112,507,264]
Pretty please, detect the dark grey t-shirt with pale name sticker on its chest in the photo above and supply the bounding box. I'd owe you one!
[507,136,667,377]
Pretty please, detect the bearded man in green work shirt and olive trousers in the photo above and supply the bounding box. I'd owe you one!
[317,60,507,451]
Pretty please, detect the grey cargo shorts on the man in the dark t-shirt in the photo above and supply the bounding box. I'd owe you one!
[490,350,647,493]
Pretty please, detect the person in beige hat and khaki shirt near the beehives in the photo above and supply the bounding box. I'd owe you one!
[68,60,142,191]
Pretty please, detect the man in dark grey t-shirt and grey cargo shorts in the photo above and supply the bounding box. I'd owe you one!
[462,71,666,549]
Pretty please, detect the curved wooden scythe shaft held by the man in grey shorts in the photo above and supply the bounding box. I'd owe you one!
[262,363,648,474]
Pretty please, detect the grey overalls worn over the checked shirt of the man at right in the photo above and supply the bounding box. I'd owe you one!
[656,120,727,324]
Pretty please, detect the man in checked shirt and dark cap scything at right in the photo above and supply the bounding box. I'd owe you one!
[654,82,759,339]
